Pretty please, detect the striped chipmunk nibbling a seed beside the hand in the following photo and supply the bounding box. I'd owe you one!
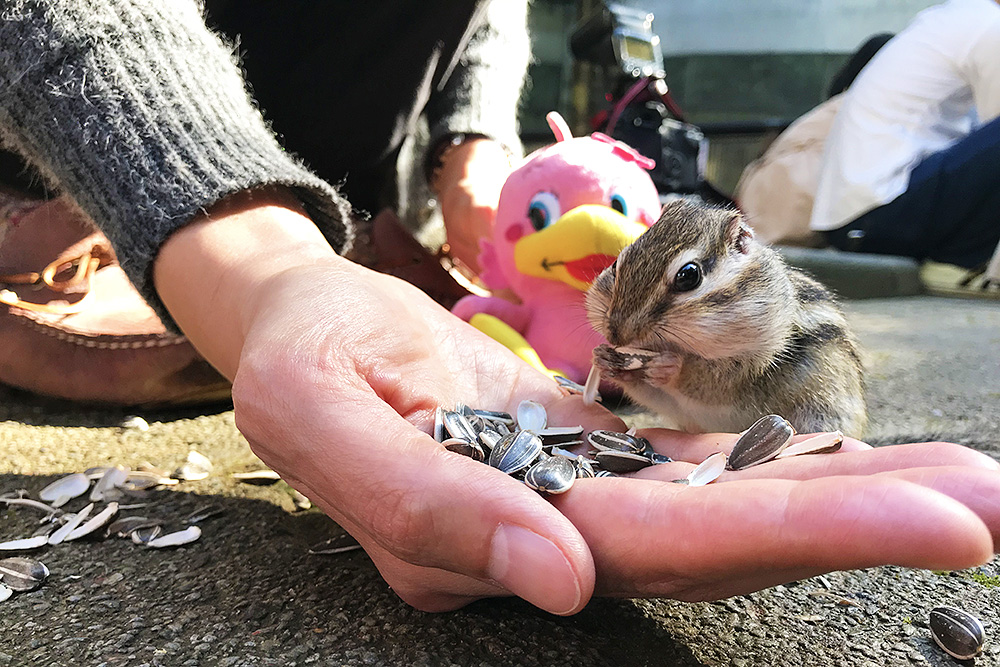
[586,201,867,436]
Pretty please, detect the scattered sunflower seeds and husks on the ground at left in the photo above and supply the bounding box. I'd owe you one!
[0,451,221,601]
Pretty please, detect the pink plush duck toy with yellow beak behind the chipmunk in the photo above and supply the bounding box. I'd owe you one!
[452,112,660,383]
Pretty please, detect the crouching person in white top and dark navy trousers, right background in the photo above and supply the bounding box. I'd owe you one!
[810,0,1000,293]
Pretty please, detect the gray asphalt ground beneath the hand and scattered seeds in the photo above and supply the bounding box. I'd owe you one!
[0,260,1000,667]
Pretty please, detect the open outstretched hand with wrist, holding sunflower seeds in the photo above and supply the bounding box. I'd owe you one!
[156,188,1000,613]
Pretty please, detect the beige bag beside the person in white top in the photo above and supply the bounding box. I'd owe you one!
[734,95,841,247]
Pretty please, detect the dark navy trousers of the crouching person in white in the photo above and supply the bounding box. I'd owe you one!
[825,118,1000,268]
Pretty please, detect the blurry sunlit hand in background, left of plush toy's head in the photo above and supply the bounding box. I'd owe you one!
[434,139,511,274]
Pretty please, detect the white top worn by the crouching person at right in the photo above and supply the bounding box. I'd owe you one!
[810,0,1000,230]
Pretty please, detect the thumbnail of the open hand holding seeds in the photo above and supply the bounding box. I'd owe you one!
[487,524,581,614]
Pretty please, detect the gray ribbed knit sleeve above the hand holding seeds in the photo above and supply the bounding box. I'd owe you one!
[0,0,351,321]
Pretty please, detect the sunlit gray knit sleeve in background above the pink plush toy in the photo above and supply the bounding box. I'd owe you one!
[427,0,531,156]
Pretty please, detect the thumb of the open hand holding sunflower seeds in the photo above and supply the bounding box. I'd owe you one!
[254,400,595,615]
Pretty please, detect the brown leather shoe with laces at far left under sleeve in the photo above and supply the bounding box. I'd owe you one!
[0,191,230,406]
